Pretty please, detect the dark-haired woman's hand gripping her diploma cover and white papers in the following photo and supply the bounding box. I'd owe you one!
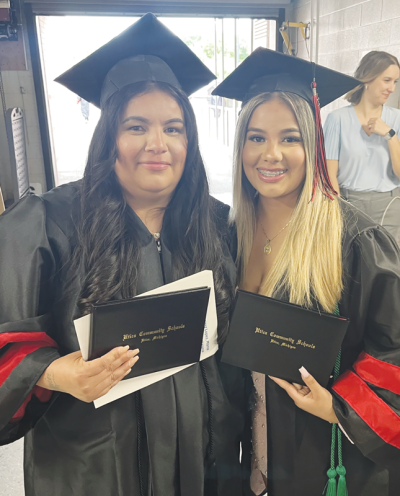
[37,346,139,403]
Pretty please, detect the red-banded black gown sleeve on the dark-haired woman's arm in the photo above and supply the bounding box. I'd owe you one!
[0,182,79,444]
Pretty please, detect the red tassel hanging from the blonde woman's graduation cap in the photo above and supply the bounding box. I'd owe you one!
[311,80,338,201]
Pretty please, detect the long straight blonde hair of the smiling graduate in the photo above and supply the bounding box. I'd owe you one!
[231,92,343,312]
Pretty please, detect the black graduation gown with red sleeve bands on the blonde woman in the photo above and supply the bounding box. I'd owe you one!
[244,204,400,496]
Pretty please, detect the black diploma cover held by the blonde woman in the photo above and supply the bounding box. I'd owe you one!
[222,290,349,387]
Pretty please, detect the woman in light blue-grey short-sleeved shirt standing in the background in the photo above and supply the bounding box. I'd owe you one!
[324,51,400,242]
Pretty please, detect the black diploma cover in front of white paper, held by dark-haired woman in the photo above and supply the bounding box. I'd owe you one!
[89,287,210,379]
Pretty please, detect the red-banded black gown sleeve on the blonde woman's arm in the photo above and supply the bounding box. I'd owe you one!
[333,227,400,467]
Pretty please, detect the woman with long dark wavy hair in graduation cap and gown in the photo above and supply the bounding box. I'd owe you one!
[0,14,242,496]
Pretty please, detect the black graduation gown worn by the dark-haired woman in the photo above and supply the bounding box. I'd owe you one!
[0,182,243,496]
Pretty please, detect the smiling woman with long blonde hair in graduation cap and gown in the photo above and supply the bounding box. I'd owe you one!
[214,48,400,496]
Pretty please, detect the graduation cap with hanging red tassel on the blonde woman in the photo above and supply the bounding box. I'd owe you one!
[212,48,361,199]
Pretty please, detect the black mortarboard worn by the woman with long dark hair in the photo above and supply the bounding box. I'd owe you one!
[56,14,215,107]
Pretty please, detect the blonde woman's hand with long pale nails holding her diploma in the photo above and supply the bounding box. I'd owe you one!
[269,367,339,424]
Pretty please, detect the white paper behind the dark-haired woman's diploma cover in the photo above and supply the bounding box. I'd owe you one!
[74,270,218,408]
